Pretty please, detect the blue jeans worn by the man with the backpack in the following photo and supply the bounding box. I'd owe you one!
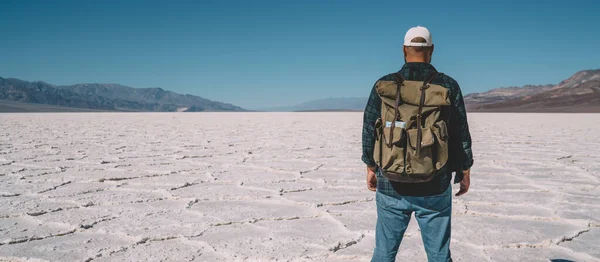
[371,186,452,262]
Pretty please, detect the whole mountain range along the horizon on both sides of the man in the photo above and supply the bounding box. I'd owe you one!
[0,69,600,113]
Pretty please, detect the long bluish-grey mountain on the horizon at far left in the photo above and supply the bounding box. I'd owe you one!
[0,77,245,112]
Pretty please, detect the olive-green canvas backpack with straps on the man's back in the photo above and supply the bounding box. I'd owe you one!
[373,71,451,183]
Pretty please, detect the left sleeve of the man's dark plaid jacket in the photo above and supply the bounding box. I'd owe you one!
[362,83,381,166]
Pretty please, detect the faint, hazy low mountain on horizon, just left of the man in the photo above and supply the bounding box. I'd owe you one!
[260,97,367,112]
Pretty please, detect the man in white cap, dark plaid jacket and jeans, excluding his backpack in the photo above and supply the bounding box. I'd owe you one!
[362,27,473,261]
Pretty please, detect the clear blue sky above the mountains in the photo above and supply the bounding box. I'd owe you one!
[0,0,600,109]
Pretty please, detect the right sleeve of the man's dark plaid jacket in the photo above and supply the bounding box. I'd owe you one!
[450,82,473,172]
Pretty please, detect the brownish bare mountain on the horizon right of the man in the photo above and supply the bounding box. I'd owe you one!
[465,69,600,112]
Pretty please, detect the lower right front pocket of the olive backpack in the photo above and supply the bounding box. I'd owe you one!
[406,128,436,176]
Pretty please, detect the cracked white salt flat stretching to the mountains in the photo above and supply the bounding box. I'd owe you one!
[0,113,600,261]
